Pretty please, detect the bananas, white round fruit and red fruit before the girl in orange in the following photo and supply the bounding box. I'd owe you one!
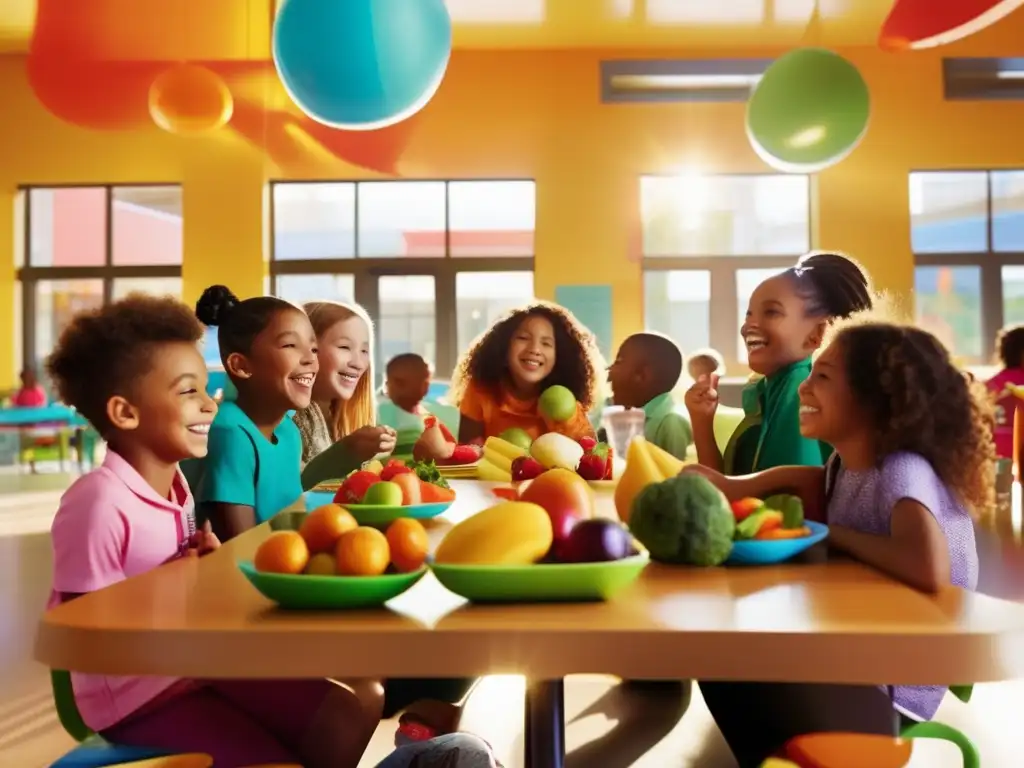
[477,429,611,482]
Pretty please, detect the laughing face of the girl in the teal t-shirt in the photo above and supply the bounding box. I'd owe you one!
[233,309,318,411]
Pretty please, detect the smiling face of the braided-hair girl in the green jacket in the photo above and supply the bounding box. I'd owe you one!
[739,274,825,376]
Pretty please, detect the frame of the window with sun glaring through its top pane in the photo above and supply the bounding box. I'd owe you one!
[637,172,814,368]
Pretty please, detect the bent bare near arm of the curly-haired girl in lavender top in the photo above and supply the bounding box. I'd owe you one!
[828,499,950,592]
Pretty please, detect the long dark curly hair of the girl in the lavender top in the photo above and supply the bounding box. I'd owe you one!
[834,321,995,515]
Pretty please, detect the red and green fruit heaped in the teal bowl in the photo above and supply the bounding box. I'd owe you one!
[334,459,455,507]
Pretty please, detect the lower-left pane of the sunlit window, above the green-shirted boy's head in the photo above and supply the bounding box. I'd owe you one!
[643,269,711,354]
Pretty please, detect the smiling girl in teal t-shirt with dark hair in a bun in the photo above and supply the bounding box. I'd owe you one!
[187,286,318,541]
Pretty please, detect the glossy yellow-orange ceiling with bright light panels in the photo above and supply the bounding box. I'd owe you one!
[0,0,893,60]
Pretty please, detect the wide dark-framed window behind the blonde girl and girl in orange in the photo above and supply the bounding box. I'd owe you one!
[270,180,537,379]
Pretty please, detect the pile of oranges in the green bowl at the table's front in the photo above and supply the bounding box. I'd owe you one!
[260,504,430,575]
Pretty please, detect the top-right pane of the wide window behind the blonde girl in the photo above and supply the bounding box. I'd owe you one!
[449,181,537,257]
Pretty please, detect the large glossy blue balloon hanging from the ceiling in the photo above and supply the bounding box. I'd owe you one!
[273,0,452,130]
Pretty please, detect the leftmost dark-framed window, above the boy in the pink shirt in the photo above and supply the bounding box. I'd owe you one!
[18,184,182,371]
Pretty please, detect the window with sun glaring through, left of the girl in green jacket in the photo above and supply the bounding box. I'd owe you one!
[640,174,811,364]
